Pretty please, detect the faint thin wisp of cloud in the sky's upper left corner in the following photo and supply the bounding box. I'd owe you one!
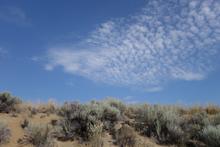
[0,6,29,25]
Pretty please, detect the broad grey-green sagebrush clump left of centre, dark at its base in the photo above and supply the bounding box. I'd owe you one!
[58,101,121,140]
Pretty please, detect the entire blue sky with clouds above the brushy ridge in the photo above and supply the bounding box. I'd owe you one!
[0,0,220,105]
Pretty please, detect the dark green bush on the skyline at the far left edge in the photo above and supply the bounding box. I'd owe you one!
[0,92,21,113]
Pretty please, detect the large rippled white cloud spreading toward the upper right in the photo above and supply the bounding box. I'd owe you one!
[45,0,220,91]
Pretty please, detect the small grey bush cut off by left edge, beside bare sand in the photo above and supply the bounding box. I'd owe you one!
[0,121,11,145]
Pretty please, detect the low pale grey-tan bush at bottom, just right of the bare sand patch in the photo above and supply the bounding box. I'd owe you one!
[18,124,55,147]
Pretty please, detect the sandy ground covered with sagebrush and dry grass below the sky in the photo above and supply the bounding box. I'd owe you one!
[0,93,220,147]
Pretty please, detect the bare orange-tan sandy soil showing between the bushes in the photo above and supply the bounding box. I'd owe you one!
[0,113,174,147]
